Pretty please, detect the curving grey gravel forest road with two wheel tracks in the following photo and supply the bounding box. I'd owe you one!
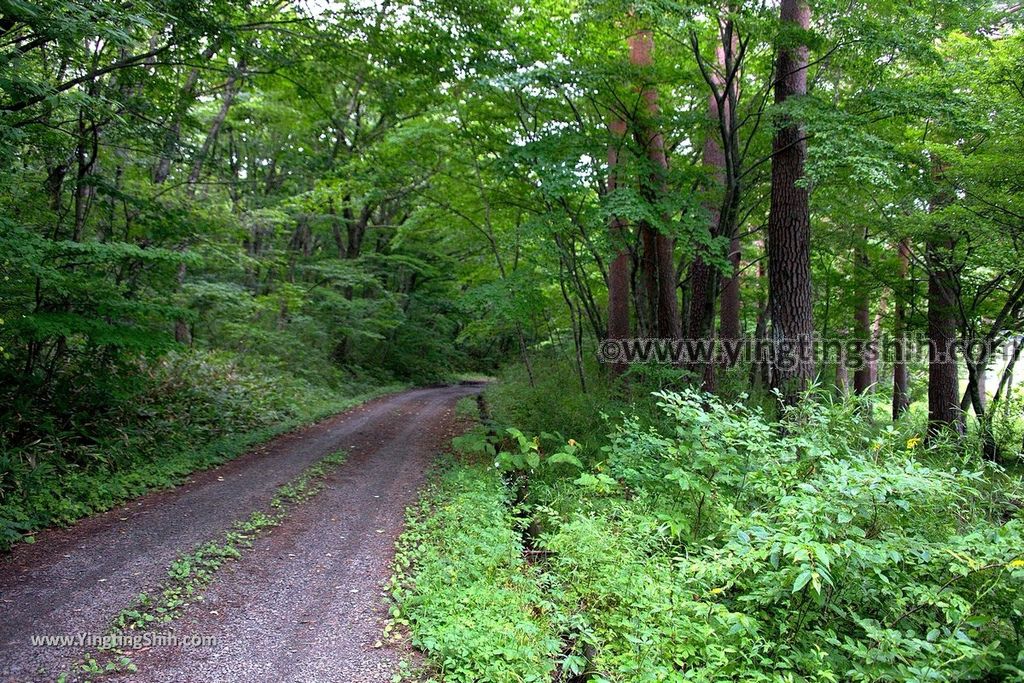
[0,385,479,683]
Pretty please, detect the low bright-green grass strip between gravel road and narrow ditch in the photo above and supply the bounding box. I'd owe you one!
[388,460,561,683]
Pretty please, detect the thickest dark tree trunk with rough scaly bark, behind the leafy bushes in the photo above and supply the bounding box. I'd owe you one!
[768,0,814,400]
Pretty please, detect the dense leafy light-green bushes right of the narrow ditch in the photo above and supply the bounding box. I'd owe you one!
[542,391,1024,683]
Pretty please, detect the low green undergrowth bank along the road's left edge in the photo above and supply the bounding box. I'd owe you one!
[0,351,399,551]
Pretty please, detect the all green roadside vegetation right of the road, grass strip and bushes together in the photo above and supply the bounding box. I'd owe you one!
[395,362,1024,683]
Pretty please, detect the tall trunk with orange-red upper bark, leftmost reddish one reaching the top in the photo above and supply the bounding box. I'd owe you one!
[629,29,682,338]
